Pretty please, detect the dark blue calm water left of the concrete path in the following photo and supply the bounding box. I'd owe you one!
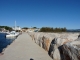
[0,33,15,53]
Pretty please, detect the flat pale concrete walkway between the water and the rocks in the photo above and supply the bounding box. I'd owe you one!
[0,33,52,60]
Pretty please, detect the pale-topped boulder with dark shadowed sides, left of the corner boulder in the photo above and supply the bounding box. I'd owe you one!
[48,33,78,60]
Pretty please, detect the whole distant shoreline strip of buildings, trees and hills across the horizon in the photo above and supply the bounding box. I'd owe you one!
[0,26,80,32]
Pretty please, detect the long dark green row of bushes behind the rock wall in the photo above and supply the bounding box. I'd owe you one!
[40,27,67,32]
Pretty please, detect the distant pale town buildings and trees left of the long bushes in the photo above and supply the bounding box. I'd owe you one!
[0,26,39,32]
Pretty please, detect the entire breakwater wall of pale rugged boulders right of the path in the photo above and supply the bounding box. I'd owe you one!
[28,32,80,60]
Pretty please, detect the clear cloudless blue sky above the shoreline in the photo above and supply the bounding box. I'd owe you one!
[0,0,80,29]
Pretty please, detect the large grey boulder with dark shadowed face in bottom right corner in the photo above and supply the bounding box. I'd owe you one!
[62,39,80,60]
